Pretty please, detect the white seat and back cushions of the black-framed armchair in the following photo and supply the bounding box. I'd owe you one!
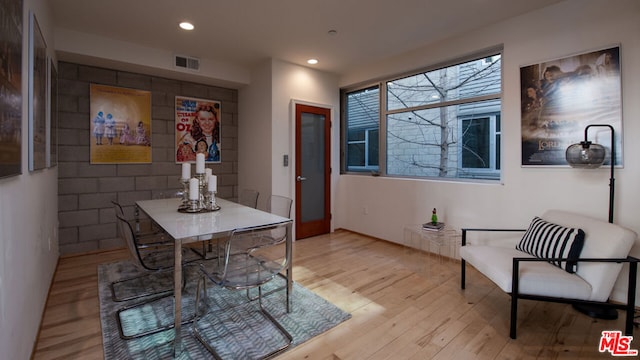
[460,210,637,301]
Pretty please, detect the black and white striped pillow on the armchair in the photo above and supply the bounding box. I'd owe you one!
[516,216,584,273]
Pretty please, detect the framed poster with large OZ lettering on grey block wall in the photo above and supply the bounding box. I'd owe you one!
[176,96,221,163]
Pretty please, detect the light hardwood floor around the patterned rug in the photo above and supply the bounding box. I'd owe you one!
[33,231,640,360]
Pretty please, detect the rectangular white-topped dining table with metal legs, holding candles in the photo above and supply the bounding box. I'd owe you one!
[136,198,293,357]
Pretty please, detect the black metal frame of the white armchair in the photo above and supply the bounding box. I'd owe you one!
[460,228,640,339]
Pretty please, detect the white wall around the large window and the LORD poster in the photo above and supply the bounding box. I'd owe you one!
[334,0,640,300]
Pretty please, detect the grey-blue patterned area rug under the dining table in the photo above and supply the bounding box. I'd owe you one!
[98,261,351,360]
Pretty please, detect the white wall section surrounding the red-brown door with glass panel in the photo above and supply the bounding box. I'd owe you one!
[238,60,340,214]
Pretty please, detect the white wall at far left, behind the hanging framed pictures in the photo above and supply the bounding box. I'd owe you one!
[0,0,58,359]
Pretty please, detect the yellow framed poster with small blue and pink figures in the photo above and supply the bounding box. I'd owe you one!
[89,84,151,164]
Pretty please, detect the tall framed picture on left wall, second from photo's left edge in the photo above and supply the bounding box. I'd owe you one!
[28,12,48,171]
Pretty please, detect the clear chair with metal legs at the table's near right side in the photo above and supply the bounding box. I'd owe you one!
[192,222,293,359]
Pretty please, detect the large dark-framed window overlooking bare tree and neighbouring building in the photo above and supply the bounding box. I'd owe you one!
[342,51,502,180]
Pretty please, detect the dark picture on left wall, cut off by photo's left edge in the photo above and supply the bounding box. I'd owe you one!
[0,0,22,178]
